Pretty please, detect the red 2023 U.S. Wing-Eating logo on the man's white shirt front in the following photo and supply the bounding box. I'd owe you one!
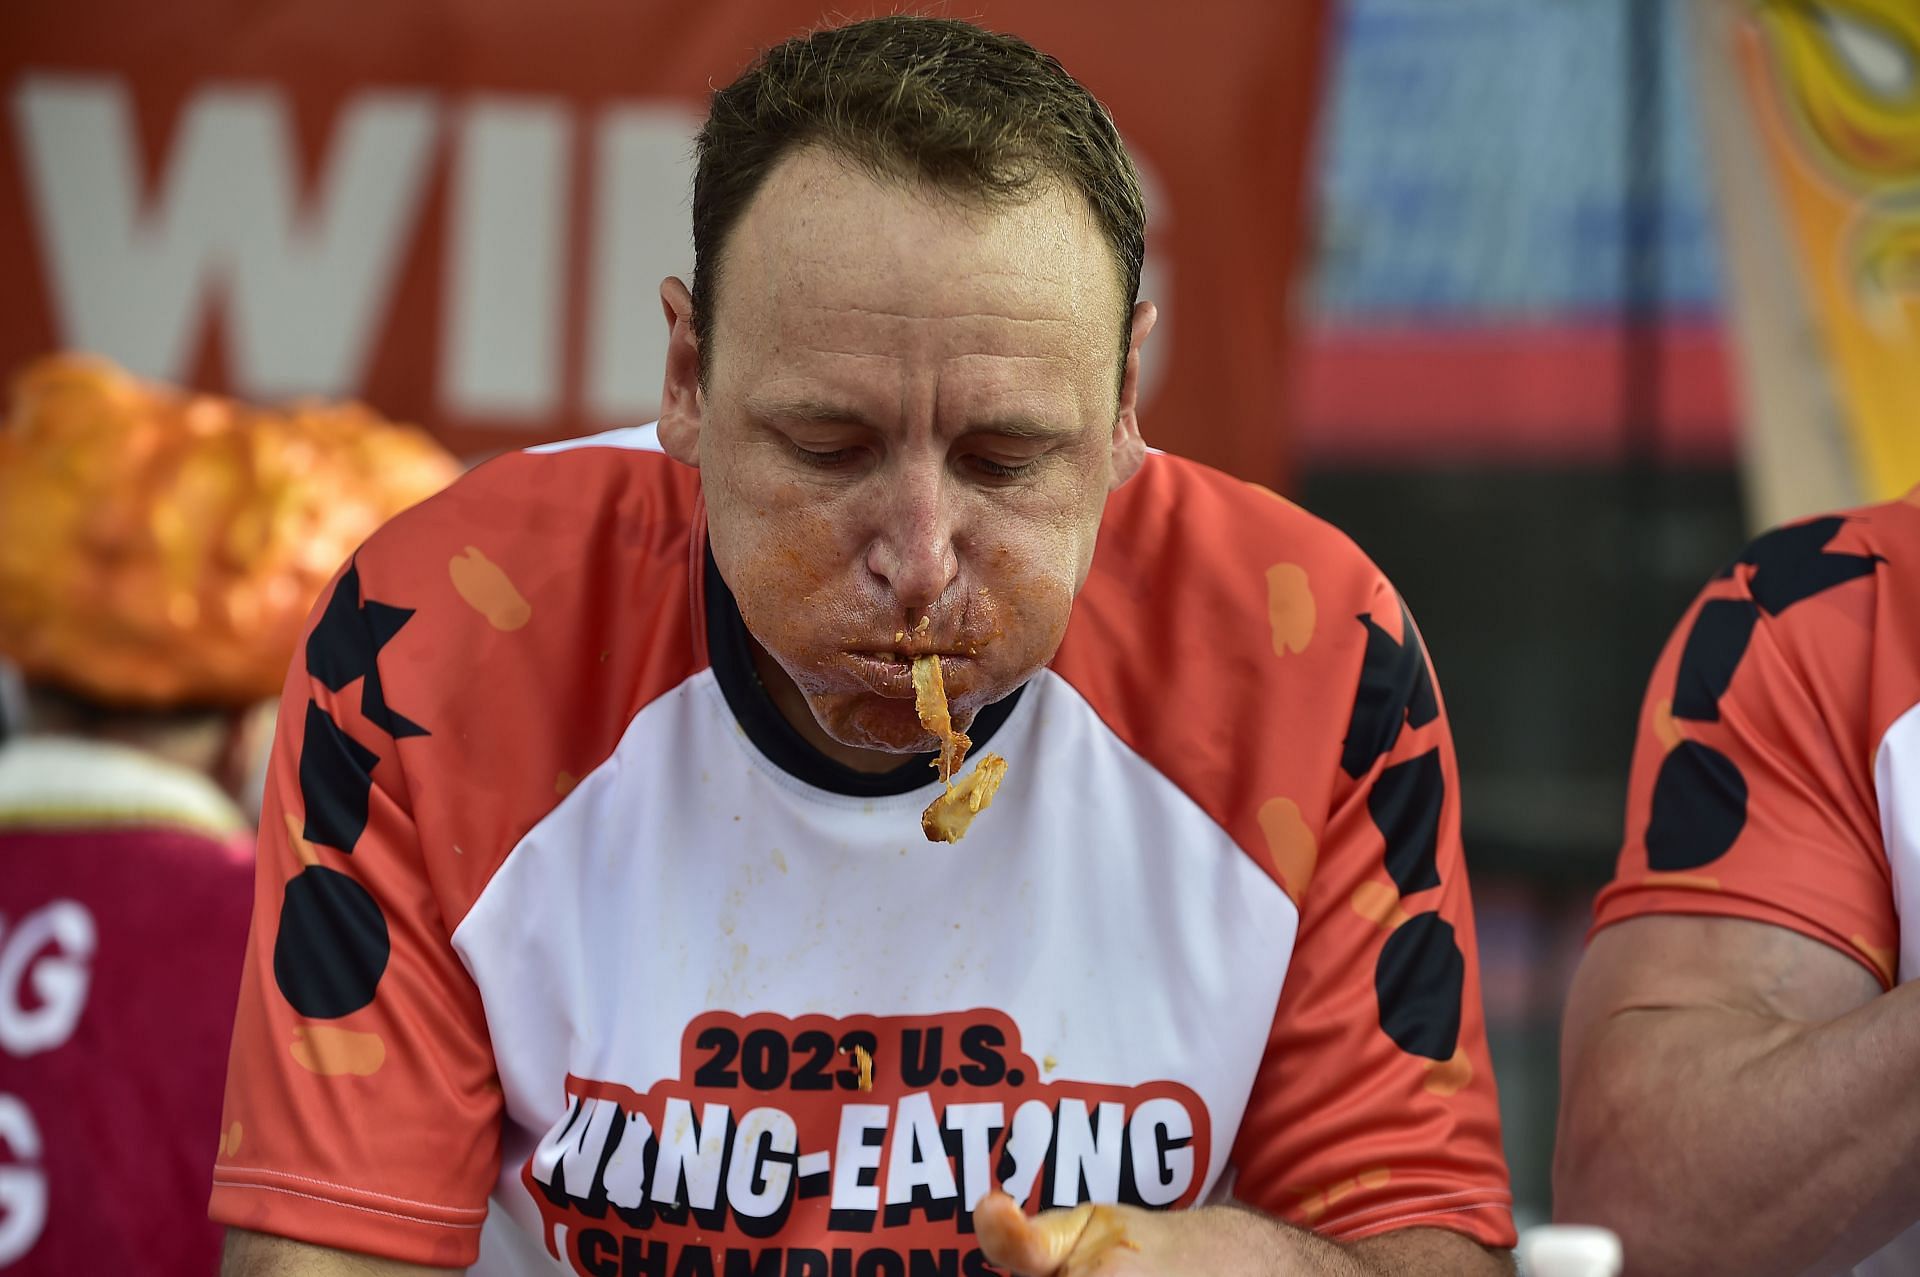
[520,1010,1212,1277]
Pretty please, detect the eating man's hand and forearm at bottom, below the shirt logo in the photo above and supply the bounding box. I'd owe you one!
[973,1193,1513,1277]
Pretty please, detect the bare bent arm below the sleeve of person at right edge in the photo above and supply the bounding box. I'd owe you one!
[1553,916,1920,1277]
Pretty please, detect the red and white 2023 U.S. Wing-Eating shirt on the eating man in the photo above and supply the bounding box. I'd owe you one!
[211,428,1513,1277]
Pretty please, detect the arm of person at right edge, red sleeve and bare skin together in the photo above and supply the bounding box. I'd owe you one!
[1553,511,1920,1277]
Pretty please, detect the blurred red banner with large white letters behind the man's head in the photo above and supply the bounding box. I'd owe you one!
[0,0,1325,482]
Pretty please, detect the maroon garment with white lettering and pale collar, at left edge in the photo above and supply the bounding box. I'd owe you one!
[0,739,253,1277]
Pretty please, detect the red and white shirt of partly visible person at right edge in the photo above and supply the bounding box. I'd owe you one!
[1594,490,1920,1275]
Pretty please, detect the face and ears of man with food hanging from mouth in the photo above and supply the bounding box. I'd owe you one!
[660,148,1152,753]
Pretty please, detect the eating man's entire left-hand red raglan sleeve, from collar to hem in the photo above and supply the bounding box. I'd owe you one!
[211,447,699,1267]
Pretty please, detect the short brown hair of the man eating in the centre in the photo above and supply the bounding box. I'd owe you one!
[693,15,1146,380]
